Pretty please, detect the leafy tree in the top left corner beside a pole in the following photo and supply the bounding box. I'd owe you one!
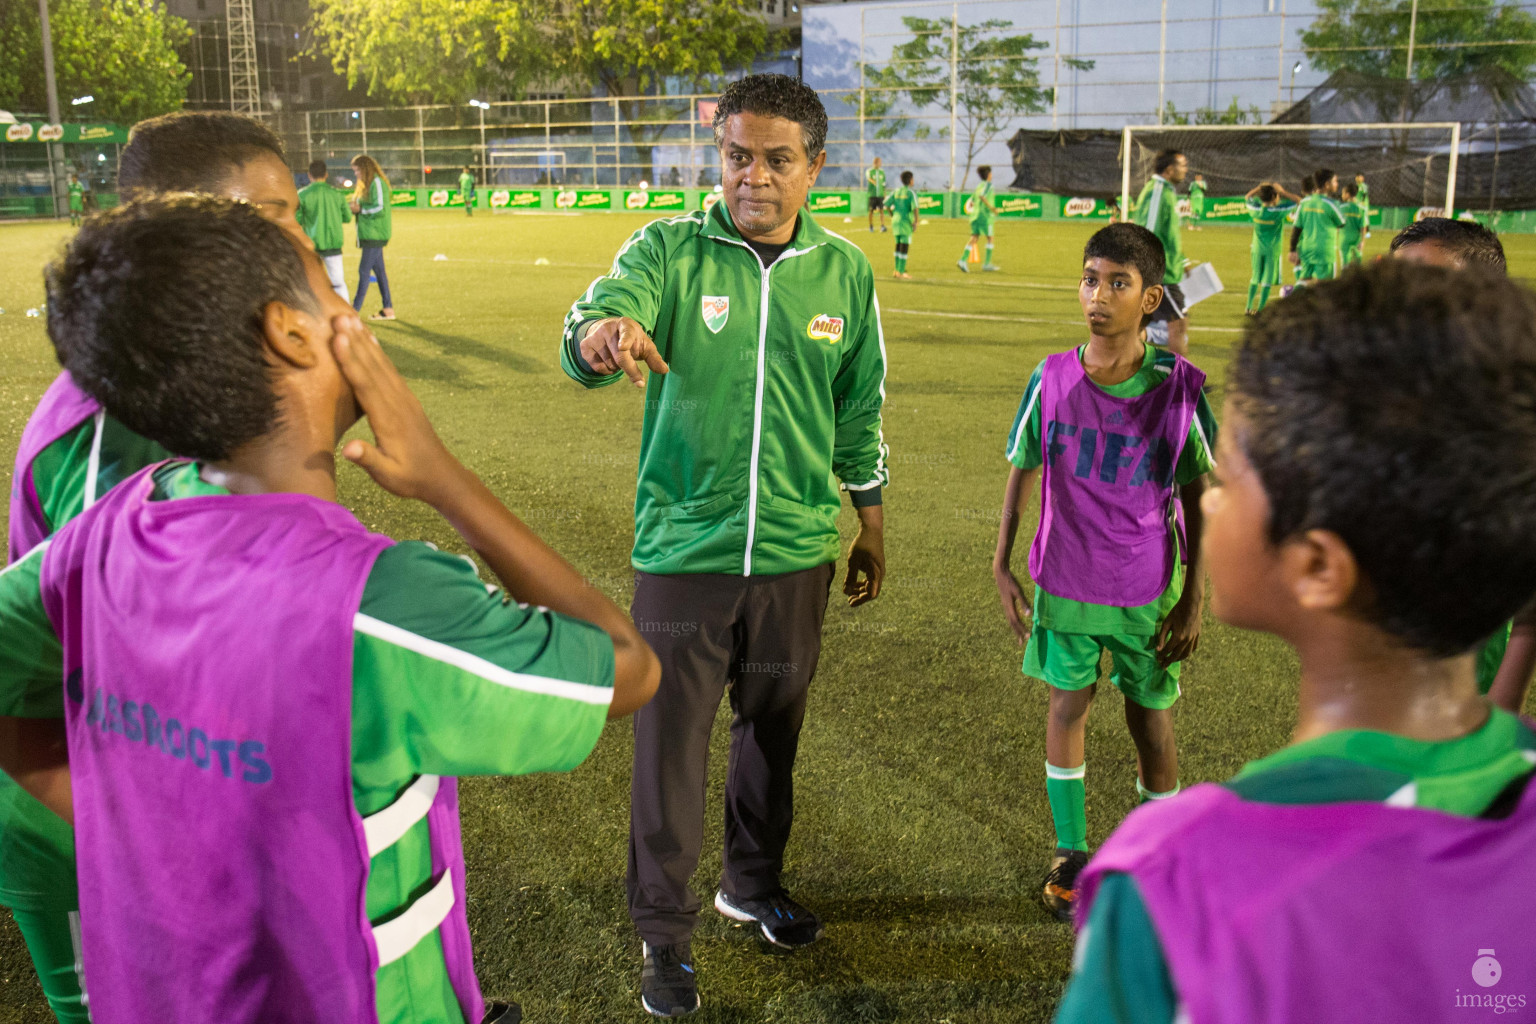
[0,0,192,124]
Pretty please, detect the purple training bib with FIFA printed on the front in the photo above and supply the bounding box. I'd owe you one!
[1029,350,1206,608]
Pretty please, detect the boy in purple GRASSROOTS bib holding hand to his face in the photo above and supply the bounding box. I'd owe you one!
[0,197,659,1024]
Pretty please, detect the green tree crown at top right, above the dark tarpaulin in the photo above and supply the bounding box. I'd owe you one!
[1301,0,1536,80]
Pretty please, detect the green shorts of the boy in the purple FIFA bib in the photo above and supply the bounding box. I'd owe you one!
[1025,625,1183,711]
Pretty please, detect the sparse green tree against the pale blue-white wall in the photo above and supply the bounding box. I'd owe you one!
[845,17,1094,188]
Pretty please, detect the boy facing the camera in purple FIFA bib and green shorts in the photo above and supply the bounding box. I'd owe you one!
[992,224,1215,921]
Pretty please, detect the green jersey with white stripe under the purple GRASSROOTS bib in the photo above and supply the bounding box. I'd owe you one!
[0,462,613,1024]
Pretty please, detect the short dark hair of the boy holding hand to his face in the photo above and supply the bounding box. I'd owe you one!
[46,193,319,461]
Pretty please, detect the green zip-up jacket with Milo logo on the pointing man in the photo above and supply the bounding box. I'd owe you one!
[561,203,889,576]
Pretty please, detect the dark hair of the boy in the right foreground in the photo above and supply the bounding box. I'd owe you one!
[1227,259,1536,657]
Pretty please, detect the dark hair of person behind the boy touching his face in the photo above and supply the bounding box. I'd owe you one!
[117,111,286,197]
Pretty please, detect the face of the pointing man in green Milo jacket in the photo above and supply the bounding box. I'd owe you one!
[720,114,826,239]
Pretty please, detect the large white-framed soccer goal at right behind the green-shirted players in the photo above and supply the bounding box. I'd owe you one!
[1120,121,1461,216]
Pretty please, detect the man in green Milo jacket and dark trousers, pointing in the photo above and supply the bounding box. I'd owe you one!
[561,75,888,1016]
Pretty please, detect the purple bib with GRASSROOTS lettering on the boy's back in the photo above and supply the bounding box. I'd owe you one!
[43,467,484,1024]
